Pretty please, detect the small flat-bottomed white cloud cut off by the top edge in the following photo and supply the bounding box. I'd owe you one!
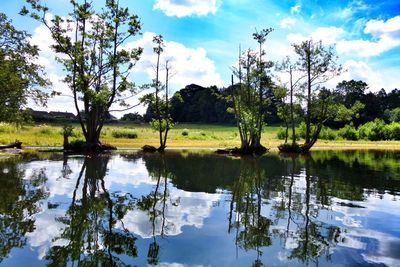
[153,0,218,18]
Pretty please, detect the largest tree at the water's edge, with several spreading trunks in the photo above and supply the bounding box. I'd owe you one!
[21,0,142,150]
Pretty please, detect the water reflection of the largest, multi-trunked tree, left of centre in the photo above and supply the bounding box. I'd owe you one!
[46,156,137,266]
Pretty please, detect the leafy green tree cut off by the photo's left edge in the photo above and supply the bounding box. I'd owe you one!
[0,13,50,123]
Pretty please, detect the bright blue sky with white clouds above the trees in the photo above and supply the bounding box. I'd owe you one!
[0,0,400,117]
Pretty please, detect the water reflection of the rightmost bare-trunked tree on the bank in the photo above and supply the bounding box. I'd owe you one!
[275,157,340,265]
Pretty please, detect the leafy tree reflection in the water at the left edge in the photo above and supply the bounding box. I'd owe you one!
[0,159,48,263]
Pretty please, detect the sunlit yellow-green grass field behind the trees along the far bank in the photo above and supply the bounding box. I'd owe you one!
[0,123,400,150]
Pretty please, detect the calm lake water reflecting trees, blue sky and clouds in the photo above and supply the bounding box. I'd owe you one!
[0,152,400,266]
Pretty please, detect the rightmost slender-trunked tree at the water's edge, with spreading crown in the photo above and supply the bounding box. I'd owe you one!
[293,39,342,152]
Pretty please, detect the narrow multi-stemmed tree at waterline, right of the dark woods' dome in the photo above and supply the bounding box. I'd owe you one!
[229,28,272,154]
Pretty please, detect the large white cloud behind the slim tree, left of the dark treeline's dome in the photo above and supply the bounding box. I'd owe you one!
[127,32,224,88]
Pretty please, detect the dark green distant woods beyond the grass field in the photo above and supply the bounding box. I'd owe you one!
[135,80,400,128]
